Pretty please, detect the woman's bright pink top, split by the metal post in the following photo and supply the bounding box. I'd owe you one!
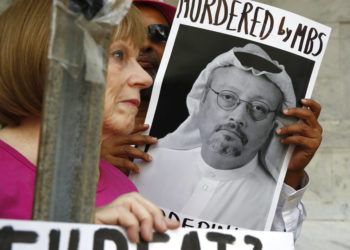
[0,140,137,219]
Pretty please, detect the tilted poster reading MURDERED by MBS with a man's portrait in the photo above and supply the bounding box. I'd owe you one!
[132,0,330,230]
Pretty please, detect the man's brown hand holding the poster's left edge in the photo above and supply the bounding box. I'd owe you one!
[101,124,157,174]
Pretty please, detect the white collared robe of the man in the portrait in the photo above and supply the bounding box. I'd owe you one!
[132,147,290,230]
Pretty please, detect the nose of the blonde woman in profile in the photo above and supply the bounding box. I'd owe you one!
[129,60,153,89]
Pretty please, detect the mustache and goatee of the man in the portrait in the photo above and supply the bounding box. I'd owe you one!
[208,123,248,157]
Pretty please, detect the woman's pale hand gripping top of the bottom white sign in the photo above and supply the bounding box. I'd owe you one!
[94,193,180,243]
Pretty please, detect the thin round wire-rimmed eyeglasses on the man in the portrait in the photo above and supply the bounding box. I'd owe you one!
[209,87,277,121]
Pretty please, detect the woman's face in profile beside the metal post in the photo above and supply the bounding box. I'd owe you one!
[103,40,152,135]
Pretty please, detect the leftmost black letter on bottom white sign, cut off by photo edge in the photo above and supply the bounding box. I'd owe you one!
[0,226,38,250]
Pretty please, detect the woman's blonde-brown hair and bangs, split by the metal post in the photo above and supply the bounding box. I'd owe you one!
[0,0,146,126]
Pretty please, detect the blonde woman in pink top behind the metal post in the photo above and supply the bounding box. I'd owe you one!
[0,0,178,242]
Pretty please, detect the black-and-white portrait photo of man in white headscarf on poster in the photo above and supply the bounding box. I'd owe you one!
[132,25,314,230]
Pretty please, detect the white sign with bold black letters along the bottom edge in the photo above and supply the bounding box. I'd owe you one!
[0,219,294,250]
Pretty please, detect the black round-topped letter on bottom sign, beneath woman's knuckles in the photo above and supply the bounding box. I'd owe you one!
[93,228,128,250]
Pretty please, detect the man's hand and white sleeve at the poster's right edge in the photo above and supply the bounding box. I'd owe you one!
[272,99,322,239]
